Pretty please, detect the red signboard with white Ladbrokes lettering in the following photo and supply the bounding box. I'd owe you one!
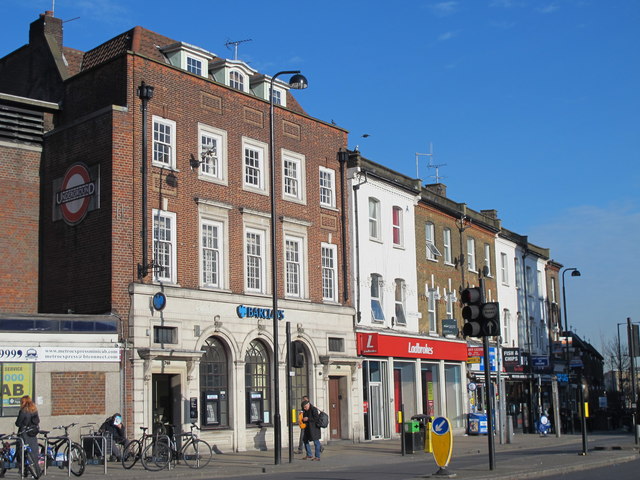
[357,333,467,362]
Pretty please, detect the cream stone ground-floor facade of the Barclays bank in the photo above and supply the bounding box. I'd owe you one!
[130,283,363,452]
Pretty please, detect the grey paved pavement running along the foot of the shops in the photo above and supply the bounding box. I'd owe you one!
[26,433,640,480]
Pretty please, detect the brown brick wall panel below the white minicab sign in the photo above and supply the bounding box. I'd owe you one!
[51,372,106,416]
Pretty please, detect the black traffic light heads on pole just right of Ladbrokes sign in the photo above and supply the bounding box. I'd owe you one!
[460,287,500,337]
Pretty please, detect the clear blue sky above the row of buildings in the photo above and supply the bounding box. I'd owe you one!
[0,0,640,358]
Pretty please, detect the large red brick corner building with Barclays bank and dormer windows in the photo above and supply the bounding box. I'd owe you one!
[0,12,361,451]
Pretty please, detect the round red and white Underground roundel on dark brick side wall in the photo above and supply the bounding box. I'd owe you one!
[56,163,96,225]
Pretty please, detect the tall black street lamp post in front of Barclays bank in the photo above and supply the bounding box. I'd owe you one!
[269,70,308,465]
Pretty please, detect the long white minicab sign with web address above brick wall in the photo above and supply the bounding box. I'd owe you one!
[0,346,120,363]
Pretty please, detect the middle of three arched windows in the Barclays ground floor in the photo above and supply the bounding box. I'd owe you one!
[244,340,273,423]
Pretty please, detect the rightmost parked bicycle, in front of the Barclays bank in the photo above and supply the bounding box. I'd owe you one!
[142,423,213,471]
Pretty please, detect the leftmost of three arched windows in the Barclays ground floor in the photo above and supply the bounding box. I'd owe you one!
[200,337,231,427]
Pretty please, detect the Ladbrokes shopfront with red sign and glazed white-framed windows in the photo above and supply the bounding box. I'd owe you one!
[357,331,467,439]
